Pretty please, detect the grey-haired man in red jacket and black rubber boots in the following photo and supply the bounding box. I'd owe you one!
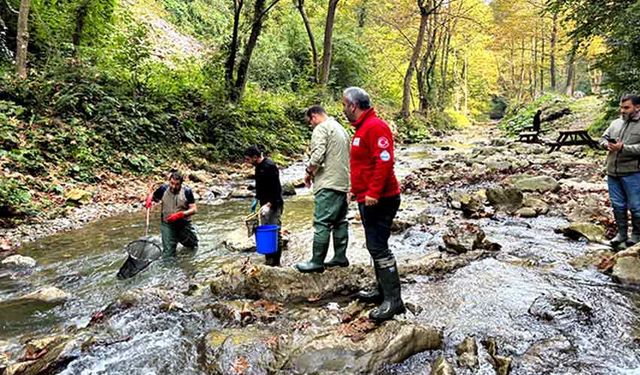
[342,87,405,321]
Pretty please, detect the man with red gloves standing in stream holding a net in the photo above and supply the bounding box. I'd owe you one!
[145,171,198,256]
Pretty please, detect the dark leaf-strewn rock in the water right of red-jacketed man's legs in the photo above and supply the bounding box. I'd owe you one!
[442,221,501,254]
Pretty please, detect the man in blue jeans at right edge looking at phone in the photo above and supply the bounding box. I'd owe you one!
[600,95,640,250]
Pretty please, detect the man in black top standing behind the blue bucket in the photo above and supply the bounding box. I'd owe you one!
[244,146,284,267]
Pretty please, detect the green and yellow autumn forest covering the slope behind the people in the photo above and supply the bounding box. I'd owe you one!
[0,0,640,223]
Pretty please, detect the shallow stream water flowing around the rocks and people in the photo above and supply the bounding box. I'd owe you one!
[0,131,640,374]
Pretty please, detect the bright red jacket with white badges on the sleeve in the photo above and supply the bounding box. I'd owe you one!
[351,108,400,203]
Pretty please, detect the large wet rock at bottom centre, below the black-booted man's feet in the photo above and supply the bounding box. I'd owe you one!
[283,320,442,374]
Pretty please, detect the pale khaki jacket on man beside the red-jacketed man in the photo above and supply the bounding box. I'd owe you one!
[309,117,351,194]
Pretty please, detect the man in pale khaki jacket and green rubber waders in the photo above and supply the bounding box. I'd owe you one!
[296,106,349,272]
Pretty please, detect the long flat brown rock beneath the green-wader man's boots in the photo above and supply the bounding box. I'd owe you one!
[209,258,371,302]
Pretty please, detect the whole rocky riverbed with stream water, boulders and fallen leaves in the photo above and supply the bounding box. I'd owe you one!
[0,125,640,374]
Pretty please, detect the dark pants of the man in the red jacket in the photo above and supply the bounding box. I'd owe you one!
[358,195,400,263]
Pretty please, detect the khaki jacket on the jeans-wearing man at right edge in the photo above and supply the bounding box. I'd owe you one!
[600,115,640,177]
